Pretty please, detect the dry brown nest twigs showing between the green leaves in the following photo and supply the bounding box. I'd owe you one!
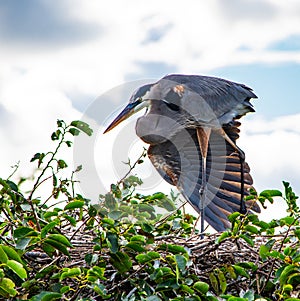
[23,225,290,296]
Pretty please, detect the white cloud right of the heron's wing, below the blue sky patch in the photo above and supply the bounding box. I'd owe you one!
[238,114,300,194]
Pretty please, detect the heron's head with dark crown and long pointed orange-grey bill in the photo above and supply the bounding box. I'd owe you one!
[104,84,155,134]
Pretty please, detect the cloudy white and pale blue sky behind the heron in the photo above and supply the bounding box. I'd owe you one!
[0,0,300,220]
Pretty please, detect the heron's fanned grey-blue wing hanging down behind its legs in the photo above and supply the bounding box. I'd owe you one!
[148,121,260,231]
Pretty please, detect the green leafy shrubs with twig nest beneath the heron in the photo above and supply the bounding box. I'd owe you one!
[0,120,300,301]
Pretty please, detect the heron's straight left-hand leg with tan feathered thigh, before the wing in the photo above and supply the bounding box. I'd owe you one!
[197,127,211,239]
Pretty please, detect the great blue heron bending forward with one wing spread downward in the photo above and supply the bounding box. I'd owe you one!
[104,74,260,232]
